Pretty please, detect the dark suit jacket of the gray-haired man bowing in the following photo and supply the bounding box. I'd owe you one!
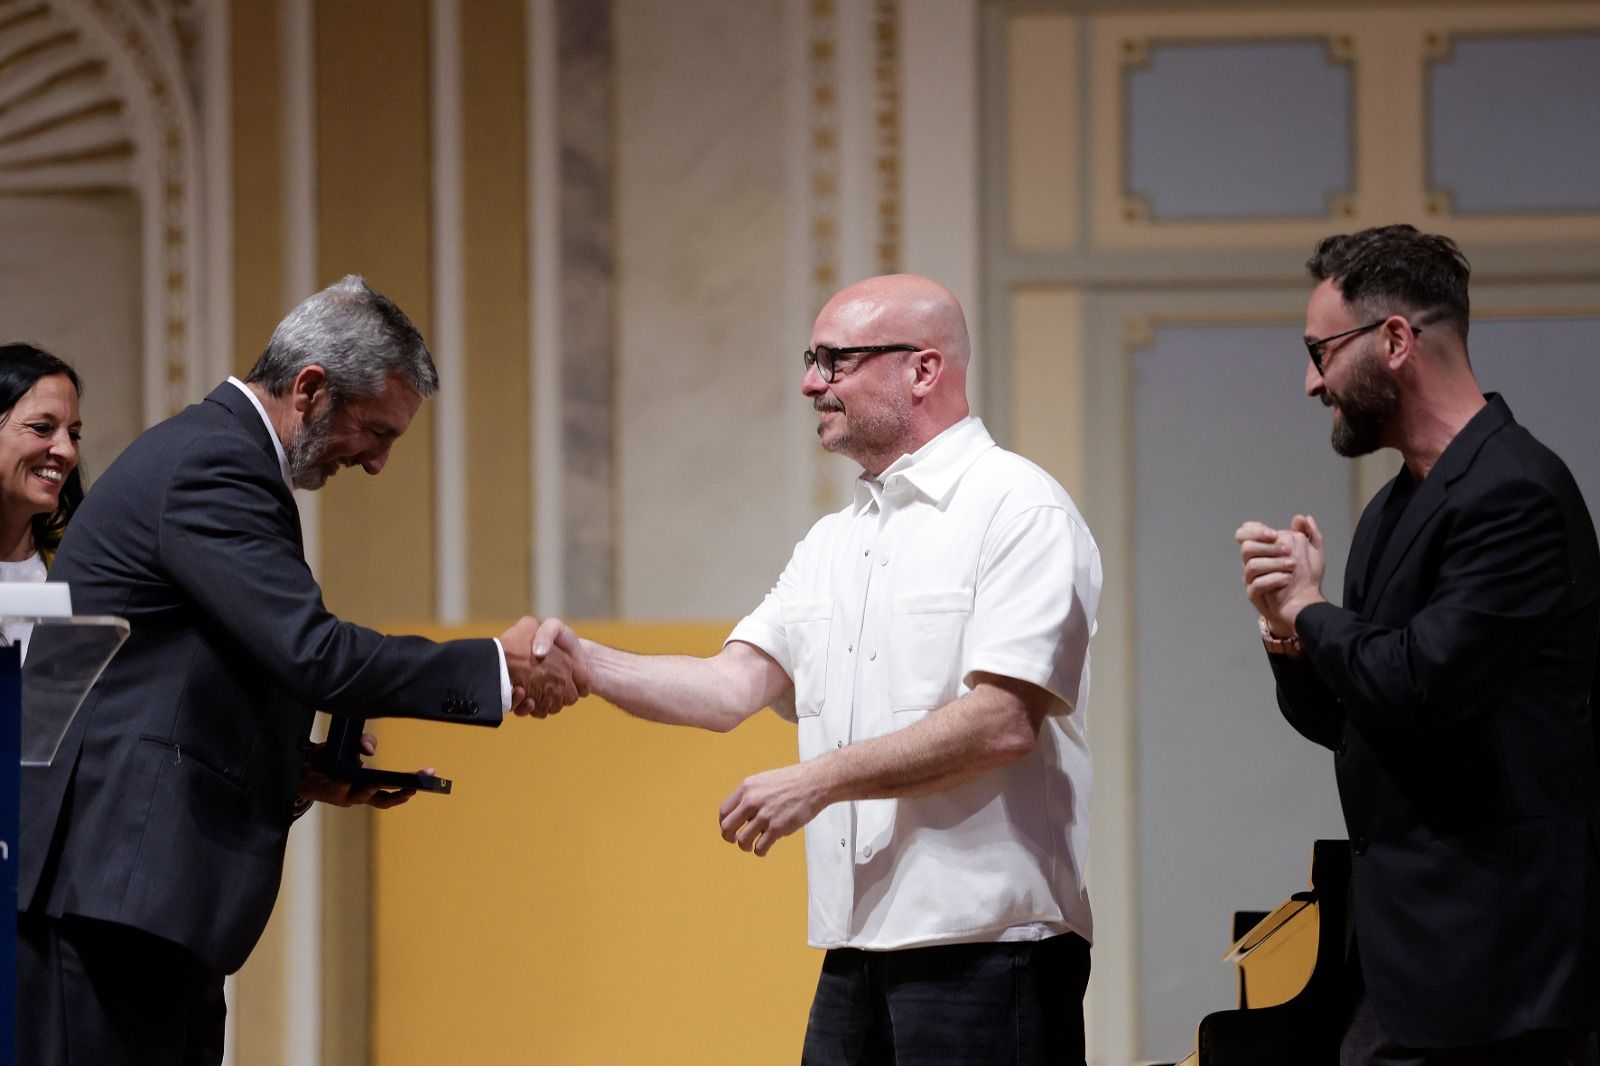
[18,383,501,972]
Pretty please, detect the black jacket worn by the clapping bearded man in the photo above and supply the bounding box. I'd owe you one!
[1270,395,1600,1047]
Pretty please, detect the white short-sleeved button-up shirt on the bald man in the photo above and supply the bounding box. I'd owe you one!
[728,418,1101,949]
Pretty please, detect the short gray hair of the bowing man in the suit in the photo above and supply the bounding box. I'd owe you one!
[246,274,438,405]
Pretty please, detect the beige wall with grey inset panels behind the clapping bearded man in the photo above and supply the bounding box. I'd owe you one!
[982,2,1600,1063]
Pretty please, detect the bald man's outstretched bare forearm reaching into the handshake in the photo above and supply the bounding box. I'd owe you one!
[582,640,770,733]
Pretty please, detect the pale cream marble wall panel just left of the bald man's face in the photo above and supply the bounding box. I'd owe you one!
[614,0,816,618]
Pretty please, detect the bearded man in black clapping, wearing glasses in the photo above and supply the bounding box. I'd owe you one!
[1235,226,1600,1066]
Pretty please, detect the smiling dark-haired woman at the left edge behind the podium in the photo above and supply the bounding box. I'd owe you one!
[0,344,83,642]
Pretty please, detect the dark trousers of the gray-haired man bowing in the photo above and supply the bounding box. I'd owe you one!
[16,914,227,1066]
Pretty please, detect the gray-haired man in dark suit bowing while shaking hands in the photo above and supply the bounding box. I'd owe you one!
[18,277,587,1066]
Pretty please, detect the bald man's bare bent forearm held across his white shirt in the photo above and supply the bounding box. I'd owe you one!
[805,685,1043,804]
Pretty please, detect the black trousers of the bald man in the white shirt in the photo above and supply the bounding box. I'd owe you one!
[802,933,1090,1066]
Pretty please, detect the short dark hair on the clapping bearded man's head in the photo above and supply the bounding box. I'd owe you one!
[1306,226,1472,338]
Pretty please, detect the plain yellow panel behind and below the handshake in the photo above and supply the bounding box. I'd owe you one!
[373,623,822,1066]
